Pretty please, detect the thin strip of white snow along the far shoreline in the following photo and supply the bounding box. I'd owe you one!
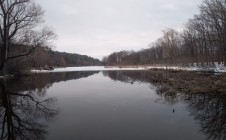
[32,64,226,73]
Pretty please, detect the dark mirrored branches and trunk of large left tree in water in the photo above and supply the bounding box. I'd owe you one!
[0,84,58,140]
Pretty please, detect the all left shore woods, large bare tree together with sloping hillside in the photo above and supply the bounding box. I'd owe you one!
[0,0,101,75]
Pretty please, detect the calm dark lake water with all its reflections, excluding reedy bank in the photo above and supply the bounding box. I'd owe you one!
[0,71,226,140]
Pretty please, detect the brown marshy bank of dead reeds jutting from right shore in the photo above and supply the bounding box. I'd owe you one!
[151,70,226,94]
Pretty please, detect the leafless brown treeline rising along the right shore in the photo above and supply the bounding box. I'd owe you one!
[103,0,226,66]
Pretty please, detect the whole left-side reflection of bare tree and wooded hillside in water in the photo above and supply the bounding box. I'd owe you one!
[0,72,97,140]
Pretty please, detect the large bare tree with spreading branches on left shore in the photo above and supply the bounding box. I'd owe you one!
[0,0,56,74]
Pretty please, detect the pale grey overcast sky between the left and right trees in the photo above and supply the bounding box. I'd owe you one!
[37,0,202,60]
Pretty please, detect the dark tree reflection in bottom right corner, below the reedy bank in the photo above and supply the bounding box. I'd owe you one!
[185,93,226,140]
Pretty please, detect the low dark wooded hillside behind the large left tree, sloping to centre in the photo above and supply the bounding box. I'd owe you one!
[8,47,102,72]
